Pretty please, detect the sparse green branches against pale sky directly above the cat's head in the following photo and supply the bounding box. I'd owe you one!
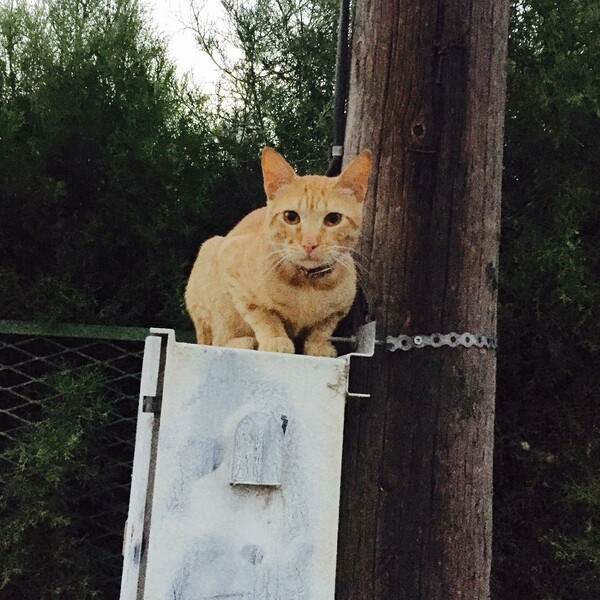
[196,0,339,173]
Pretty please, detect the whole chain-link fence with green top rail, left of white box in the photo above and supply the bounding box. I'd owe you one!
[0,321,190,600]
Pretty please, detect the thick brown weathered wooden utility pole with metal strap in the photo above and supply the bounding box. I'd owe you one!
[337,0,509,600]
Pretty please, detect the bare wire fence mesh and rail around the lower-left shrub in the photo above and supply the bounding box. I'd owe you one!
[0,321,192,599]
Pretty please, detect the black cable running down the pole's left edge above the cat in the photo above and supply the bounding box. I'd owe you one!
[325,0,350,177]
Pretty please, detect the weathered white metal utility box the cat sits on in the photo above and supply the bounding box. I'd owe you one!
[121,330,370,600]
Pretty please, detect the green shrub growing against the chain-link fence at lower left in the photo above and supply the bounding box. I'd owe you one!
[0,369,115,600]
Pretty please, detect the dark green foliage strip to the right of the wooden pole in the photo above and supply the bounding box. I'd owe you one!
[494,0,600,600]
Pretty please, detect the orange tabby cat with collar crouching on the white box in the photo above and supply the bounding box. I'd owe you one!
[185,148,371,356]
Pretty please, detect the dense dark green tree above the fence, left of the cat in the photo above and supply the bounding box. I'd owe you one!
[0,0,219,324]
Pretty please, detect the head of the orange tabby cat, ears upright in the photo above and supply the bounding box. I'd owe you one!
[262,148,371,269]
